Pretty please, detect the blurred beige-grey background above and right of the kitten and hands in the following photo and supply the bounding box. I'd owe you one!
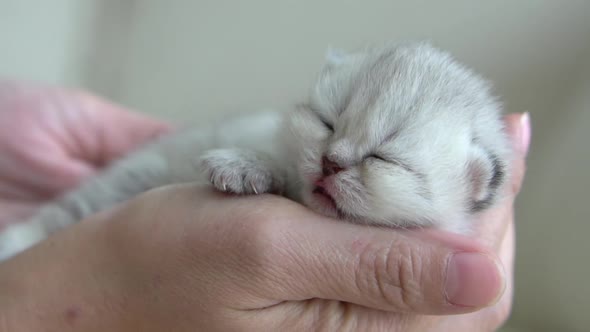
[0,0,590,331]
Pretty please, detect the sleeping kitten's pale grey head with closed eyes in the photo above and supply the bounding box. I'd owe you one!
[287,43,507,230]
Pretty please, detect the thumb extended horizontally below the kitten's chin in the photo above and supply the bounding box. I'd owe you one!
[256,204,505,315]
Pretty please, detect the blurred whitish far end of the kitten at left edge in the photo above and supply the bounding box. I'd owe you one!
[0,223,46,262]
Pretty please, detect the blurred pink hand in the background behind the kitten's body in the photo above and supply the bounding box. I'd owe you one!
[0,81,168,228]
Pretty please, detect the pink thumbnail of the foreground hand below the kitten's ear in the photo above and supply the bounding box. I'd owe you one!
[445,252,504,307]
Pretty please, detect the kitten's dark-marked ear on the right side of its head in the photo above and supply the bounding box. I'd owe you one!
[467,145,504,211]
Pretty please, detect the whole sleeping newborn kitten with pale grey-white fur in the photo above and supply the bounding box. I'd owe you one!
[0,43,510,260]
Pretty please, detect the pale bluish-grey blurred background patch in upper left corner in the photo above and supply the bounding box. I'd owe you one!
[0,0,99,85]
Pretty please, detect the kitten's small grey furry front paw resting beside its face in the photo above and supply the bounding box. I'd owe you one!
[201,149,283,195]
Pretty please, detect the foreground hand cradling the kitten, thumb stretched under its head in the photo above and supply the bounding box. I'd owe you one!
[0,116,528,331]
